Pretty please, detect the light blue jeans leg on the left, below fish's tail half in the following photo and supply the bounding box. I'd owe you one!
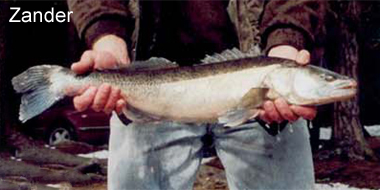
[108,114,206,190]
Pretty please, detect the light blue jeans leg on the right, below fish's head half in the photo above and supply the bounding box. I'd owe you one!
[213,119,314,190]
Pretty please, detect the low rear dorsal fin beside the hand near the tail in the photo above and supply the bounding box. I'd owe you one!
[102,57,178,72]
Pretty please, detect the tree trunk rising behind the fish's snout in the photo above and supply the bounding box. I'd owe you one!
[330,1,376,160]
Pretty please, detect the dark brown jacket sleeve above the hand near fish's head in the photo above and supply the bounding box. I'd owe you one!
[260,0,327,52]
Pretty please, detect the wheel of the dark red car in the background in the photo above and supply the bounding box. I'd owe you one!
[47,123,75,145]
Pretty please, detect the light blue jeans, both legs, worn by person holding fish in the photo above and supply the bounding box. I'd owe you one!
[108,114,314,190]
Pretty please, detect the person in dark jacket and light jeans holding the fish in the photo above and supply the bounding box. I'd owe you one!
[68,0,326,189]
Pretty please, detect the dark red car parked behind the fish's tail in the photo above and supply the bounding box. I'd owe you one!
[23,100,110,145]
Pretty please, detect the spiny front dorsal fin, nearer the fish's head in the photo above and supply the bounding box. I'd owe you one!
[201,46,261,64]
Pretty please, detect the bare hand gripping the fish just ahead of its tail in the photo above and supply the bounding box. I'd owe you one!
[66,35,130,114]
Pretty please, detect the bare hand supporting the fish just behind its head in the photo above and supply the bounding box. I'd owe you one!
[259,45,317,123]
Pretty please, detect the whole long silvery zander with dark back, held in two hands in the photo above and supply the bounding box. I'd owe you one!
[12,49,357,126]
